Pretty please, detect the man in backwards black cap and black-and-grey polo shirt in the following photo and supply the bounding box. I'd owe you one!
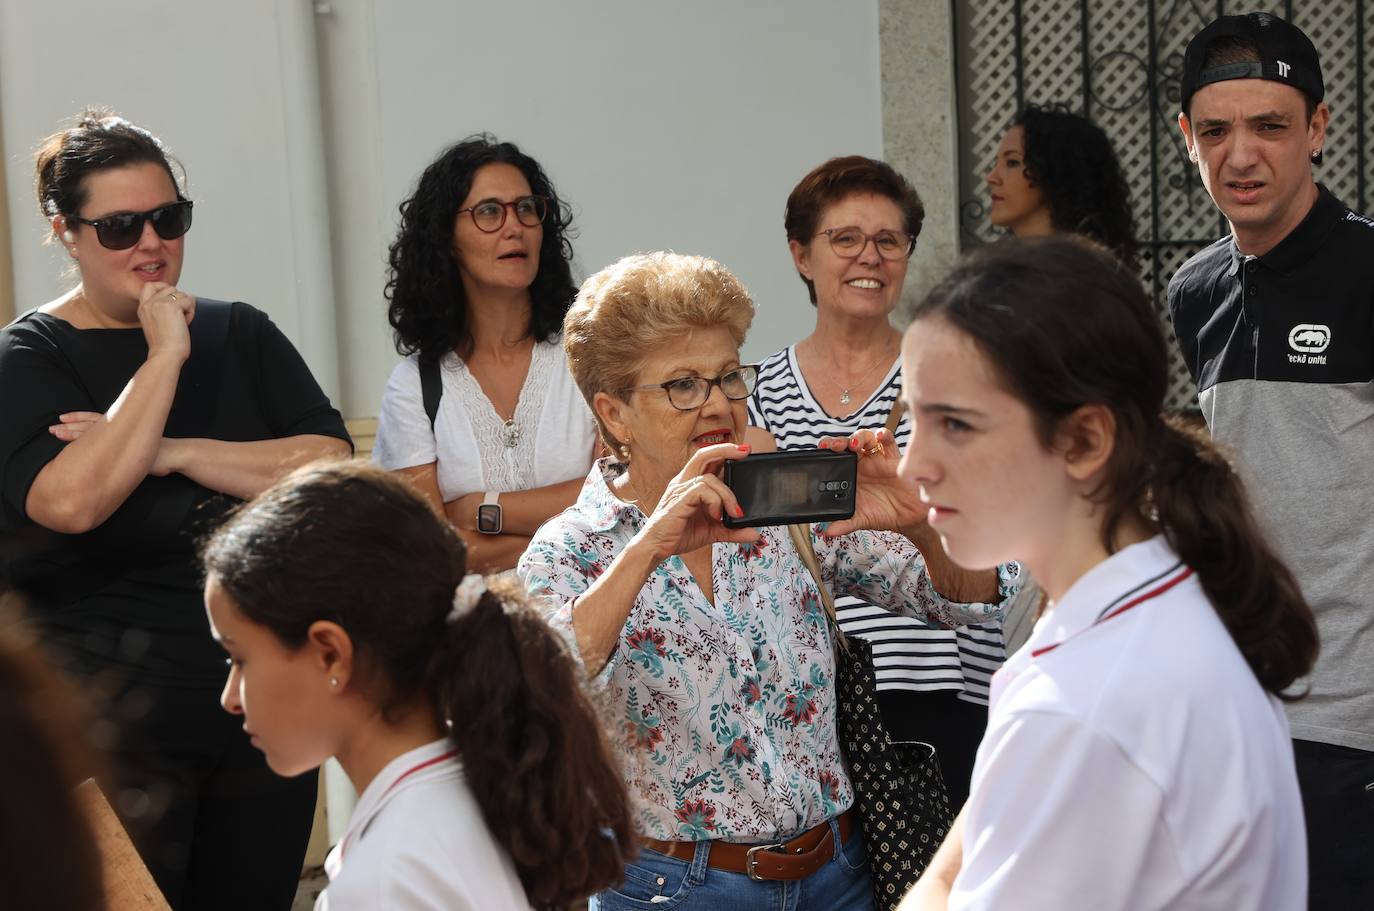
[1169,12,1374,908]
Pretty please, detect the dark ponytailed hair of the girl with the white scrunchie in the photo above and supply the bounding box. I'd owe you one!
[202,462,636,908]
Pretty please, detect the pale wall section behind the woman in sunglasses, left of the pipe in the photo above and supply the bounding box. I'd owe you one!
[0,0,338,396]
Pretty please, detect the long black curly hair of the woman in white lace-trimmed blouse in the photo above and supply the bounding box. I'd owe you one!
[385,133,577,360]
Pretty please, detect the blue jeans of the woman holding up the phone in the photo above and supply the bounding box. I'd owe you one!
[589,819,872,911]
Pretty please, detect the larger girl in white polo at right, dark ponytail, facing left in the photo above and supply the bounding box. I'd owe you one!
[841,238,1316,911]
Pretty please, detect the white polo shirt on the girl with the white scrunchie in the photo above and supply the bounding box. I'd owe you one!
[315,739,529,911]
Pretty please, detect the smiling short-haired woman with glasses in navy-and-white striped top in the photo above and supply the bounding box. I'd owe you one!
[749,155,1004,807]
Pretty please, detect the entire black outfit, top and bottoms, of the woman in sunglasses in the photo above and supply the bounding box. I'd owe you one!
[0,301,348,910]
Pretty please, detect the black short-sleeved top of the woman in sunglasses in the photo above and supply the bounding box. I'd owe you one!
[0,301,349,684]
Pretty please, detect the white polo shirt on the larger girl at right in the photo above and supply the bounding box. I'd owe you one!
[949,537,1307,911]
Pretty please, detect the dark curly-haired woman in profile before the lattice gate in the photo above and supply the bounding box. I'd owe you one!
[987,104,1140,272]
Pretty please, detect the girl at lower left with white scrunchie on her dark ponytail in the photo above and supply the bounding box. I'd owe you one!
[203,462,633,911]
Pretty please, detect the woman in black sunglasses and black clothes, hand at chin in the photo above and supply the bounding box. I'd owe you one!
[0,111,350,908]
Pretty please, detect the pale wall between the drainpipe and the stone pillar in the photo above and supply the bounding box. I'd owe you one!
[353,0,882,414]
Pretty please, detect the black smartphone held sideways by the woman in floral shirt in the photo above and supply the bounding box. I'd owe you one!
[724,449,859,528]
